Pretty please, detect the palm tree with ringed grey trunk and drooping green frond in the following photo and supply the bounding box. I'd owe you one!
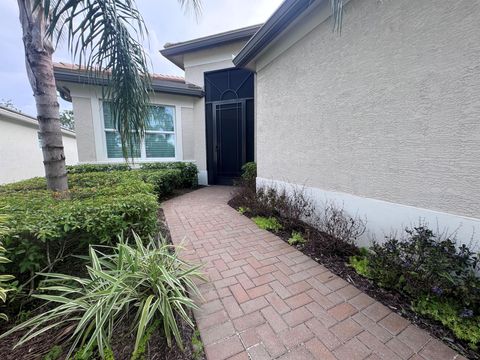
[17,0,200,192]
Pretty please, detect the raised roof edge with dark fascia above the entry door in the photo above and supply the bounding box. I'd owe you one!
[160,24,262,69]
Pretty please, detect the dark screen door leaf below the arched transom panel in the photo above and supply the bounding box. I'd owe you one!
[213,101,246,185]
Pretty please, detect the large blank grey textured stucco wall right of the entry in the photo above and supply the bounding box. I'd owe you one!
[257,0,480,218]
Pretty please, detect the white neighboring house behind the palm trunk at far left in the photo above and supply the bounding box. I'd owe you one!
[0,107,78,184]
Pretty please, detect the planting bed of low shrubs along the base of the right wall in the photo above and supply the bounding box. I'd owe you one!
[230,164,480,359]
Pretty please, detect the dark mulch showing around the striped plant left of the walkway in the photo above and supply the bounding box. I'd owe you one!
[0,189,205,360]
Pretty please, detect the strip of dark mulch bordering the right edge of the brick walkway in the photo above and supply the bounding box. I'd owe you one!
[228,196,480,359]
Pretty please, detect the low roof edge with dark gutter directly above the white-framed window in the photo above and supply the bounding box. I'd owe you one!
[53,63,203,97]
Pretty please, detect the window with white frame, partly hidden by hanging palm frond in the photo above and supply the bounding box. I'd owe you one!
[103,102,175,159]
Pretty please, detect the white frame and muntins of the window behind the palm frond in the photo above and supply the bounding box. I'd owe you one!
[100,100,181,162]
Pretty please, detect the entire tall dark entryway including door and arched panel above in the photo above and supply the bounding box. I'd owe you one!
[205,69,254,185]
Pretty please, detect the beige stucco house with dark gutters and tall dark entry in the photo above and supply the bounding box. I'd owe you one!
[56,0,480,242]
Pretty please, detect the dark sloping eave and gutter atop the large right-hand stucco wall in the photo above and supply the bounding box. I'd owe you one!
[233,0,316,67]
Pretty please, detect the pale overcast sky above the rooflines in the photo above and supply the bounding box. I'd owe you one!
[0,0,282,116]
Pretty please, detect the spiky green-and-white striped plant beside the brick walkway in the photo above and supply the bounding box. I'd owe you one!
[0,234,201,357]
